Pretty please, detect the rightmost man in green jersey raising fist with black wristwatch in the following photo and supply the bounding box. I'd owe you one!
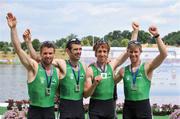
[115,26,167,119]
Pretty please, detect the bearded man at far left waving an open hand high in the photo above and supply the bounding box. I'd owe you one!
[6,13,59,119]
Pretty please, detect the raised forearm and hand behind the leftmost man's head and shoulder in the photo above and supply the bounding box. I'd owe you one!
[23,29,41,62]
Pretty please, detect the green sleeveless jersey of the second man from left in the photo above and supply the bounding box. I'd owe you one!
[60,61,85,100]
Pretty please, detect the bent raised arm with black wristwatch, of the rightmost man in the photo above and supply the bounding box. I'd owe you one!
[146,26,167,75]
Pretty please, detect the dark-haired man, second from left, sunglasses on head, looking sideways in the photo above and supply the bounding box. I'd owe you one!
[23,29,86,119]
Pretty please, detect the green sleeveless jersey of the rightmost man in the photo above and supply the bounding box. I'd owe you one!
[123,63,151,101]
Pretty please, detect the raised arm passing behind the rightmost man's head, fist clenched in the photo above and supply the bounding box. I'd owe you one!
[110,22,139,70]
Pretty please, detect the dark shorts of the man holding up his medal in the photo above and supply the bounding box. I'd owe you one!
[89,99,114,119]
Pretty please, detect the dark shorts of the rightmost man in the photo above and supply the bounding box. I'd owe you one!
[123,99,152,119]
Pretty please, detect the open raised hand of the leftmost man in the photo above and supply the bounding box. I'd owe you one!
[6,12,17,29]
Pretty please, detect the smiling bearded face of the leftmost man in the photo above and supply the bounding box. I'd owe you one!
[40,47,55,66]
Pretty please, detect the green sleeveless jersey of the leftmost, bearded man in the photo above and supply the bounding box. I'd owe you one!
[28,64,59,107]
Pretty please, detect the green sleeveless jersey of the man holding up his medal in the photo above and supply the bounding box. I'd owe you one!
[91,64,114,100]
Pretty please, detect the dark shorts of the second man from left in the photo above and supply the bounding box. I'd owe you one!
[59,99,85,119]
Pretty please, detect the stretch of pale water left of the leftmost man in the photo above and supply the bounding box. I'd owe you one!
[0,65,28,102]
